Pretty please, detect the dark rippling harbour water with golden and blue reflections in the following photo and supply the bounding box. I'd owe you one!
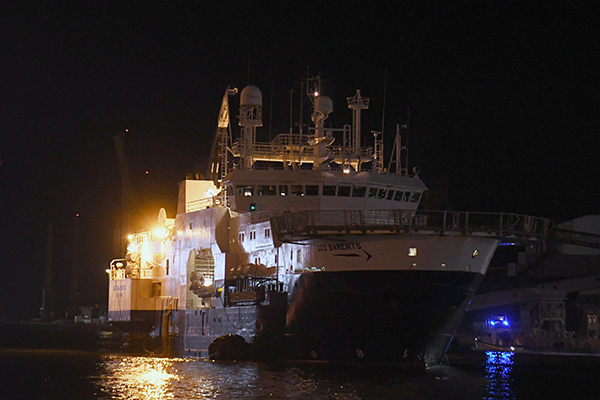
[0,349,600,400]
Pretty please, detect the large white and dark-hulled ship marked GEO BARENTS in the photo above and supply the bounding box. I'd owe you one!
[107,77,550,367]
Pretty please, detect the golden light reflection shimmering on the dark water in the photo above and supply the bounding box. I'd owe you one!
[97,356,318,400]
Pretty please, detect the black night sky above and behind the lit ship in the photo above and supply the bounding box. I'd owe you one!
[0,0,600,319]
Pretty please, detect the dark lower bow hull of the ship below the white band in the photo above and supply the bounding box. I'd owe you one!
[286,271,483,365]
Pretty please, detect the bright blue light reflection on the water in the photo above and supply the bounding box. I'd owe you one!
[483,351,516,400]
